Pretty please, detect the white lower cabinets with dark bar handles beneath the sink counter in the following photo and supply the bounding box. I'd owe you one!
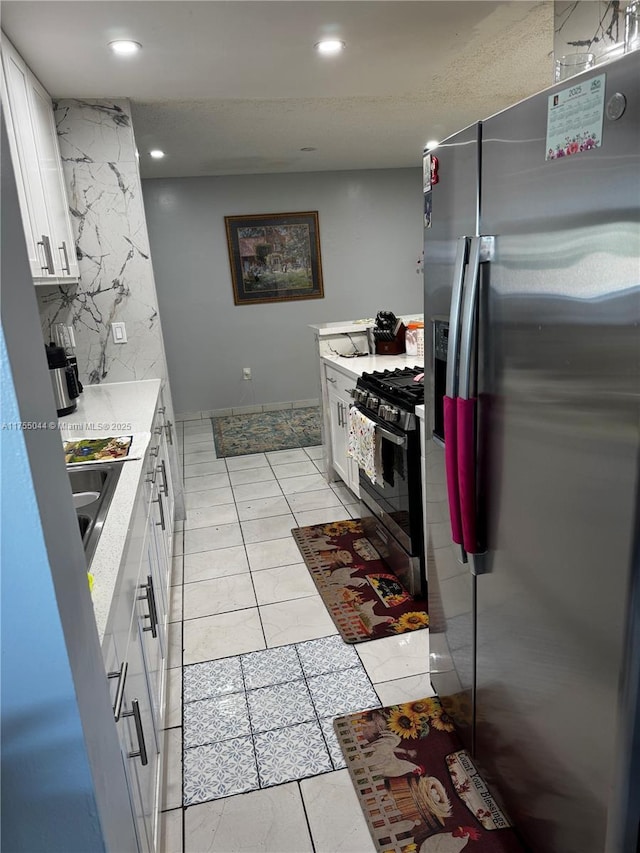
[103,398,173,853]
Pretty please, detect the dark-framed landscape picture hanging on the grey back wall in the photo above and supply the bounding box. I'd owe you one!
[224,210,324,305]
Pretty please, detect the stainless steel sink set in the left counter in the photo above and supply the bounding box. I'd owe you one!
[67,462,124,566]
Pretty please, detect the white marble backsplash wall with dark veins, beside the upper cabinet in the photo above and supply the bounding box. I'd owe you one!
[37,100,167,384]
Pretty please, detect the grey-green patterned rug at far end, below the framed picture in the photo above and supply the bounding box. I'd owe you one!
[211,406,322,458]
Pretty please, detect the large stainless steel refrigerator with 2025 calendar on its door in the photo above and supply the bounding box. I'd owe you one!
[424,52,640,853]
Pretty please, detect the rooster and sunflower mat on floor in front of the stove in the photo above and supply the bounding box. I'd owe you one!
[291,519,429,643]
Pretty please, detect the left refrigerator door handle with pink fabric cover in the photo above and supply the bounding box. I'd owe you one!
[442,237,469,548]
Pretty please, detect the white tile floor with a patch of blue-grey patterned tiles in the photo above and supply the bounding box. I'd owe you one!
[161,419,432,853]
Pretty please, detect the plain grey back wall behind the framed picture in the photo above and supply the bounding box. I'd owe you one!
[142,168,422,412]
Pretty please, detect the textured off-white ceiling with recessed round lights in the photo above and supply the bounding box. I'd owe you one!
[2,0,553,177]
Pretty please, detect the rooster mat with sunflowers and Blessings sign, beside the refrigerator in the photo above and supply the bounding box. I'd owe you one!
[333,697,524,853]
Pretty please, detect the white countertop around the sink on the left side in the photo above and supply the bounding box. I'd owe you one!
[59,379,160,641]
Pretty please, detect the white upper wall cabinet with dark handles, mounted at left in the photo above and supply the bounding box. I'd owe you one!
[2,33,79,284]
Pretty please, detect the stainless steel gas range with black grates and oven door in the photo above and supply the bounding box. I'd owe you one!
[352,367,427,597]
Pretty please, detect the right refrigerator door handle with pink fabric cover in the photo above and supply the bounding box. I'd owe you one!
[456,237,495,554]
